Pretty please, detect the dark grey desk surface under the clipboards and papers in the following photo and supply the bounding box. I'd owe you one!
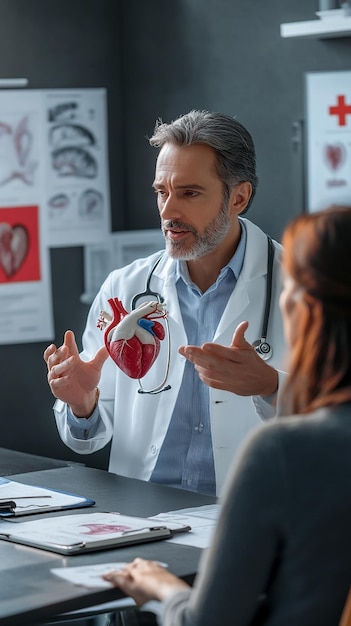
[0,465,216,626]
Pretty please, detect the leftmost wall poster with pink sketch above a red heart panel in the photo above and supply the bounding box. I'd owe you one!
[0,91,53,344]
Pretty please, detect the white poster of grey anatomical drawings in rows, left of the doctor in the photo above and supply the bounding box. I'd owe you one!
[44,89,110,246]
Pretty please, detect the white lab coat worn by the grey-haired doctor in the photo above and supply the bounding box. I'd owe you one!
[54,220,285,493]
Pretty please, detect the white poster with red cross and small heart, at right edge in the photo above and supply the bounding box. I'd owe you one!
[306,71,351,211]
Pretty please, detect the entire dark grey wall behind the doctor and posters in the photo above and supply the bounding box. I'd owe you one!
[0,0,351,467]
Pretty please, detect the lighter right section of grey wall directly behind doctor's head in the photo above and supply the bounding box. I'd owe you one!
[122,0,351,238]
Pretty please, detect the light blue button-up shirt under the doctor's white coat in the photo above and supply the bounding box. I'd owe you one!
[68,222,246,495]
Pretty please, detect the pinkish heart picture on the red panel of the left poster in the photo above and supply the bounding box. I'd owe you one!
[0,222,29,278]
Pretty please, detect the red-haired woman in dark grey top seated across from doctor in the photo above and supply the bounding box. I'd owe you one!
[105,206,351,626]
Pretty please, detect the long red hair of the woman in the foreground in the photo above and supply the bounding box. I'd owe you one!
[282,205,351,414]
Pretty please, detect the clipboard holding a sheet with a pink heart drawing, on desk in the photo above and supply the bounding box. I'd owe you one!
[0,513,191,556]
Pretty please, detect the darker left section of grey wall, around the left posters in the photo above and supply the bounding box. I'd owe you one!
[0,0,125,467]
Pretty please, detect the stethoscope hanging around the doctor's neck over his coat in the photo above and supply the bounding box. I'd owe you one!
[131,235,274,395]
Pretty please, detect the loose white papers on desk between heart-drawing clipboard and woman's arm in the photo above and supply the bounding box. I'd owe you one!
[149,504,220,548]
